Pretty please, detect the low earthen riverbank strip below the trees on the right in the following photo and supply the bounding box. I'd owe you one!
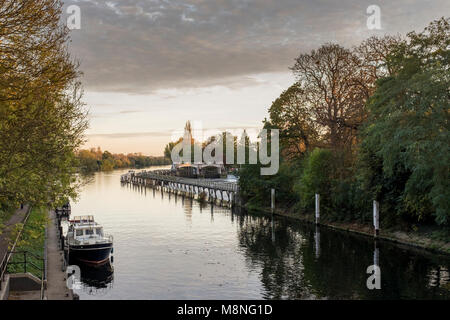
[242,204,450,255]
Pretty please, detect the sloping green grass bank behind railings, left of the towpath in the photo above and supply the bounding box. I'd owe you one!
[8,208,48,278]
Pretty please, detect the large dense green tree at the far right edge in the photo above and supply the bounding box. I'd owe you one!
[361,18,450,224]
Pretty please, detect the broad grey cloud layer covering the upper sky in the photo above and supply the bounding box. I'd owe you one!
[65,0,450,93]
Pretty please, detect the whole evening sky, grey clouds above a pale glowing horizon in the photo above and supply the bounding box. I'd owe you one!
[63,0,450,156]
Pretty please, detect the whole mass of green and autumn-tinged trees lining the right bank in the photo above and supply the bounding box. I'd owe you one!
[240,18,450,228]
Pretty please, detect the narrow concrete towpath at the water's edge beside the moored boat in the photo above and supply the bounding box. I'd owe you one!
[46,210,73,300]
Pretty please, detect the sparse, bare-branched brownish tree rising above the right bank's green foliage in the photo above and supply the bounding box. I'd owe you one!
[290,36,399,155]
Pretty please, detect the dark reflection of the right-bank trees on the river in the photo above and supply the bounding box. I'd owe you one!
[239,215,450,299]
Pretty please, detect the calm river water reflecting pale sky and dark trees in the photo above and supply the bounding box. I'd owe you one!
[72,170,450,299]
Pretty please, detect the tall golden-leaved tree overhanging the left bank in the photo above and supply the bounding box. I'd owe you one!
[0,0,87,211]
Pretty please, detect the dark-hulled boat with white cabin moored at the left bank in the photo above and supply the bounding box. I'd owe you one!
[65,216,113,264]
